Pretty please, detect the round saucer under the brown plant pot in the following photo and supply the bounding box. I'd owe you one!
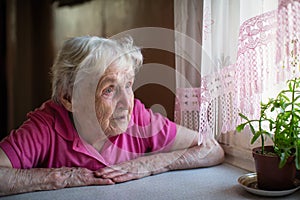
[238,173,300,197]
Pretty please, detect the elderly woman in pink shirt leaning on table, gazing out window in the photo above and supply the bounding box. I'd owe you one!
[0,36,224,195]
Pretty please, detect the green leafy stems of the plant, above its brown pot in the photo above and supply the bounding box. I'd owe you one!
[236,77,300,169]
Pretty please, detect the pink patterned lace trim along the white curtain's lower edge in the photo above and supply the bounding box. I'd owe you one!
[175,0,300,134]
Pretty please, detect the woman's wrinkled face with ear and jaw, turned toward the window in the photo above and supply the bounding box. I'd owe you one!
[72,63,135,148]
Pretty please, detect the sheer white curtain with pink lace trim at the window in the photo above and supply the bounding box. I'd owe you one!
[174,0,300,144]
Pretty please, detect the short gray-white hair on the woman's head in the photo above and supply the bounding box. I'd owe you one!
[52,36,143,104]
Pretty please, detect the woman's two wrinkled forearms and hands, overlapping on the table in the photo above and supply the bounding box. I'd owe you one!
[0,136,224,196]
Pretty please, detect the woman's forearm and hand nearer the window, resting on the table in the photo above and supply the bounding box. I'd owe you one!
[95,138,224,183]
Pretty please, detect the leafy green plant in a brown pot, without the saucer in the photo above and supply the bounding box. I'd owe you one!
[236,77,300,190]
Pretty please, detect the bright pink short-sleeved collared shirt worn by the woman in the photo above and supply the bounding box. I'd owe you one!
[0,99,176,170]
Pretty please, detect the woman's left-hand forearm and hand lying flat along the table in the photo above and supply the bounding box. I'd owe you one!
[0,167,113,196]
